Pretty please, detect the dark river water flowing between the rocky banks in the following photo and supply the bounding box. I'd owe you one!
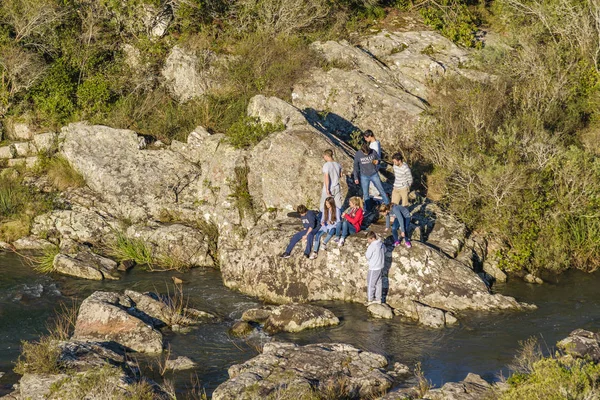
[0,253,600,394]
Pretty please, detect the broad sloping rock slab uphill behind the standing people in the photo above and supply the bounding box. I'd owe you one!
[292,31,487,148]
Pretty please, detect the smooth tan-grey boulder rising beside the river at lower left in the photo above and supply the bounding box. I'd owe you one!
[73,292,163,353]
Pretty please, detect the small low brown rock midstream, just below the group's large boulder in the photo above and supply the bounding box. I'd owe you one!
[242,304,340,334]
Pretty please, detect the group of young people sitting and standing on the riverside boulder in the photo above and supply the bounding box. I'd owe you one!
[281,130,412,304]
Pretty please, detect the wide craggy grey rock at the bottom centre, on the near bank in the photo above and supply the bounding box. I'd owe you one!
[213,343,394,400]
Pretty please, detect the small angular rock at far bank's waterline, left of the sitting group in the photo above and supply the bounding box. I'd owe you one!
[53,251,119,281]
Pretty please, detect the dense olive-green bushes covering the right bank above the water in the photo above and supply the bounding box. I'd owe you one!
[418,0,600,272]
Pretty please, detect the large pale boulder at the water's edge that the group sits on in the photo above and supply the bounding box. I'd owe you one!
[221,222,531,326]
